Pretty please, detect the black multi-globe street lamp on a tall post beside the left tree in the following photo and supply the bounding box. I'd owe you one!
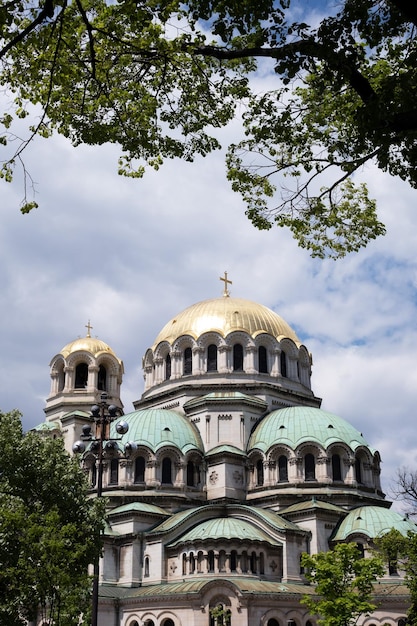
[72,392,129,626]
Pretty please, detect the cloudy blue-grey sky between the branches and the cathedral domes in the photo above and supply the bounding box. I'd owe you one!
[0,6,417,508]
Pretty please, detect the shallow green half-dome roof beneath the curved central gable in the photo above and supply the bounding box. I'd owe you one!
[166,517,278,546]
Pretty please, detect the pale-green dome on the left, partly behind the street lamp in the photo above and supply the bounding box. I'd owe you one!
[110,409,204,454]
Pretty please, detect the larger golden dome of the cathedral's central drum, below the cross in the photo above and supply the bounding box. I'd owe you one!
[153,296,300,348]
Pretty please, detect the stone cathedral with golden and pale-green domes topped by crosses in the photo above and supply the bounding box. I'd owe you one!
[37,274,417,626]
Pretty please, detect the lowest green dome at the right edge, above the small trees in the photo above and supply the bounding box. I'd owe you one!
[332,506,417,541]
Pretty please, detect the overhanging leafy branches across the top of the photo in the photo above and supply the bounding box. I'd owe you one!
[0,0,417,257]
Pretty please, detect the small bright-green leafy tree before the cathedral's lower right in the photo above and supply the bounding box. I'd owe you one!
[302,543,384,626]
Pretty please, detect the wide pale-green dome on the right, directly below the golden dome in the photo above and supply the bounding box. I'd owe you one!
[248,406,374,452]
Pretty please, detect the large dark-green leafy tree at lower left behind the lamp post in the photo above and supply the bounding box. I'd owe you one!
[0,411,103,626]
